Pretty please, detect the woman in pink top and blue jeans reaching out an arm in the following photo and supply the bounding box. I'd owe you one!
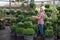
[32,7,44,40]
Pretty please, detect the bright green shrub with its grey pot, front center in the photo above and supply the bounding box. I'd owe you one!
[23,28,35,40]
